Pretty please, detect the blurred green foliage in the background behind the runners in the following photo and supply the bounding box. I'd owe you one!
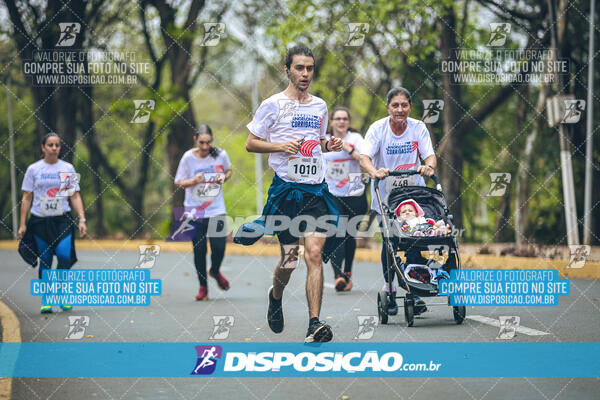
[0,0,600,243]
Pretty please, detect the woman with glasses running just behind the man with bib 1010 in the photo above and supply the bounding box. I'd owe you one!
[323,106,367,292]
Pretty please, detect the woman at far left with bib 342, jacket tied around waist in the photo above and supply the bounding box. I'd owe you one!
[18,132,87,314]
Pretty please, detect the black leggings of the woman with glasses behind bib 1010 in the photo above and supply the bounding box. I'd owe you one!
[325,194,367,276]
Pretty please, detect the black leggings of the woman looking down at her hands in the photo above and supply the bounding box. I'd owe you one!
[192,215,227,286]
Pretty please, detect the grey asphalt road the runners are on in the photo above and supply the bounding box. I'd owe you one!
[0,250,600,400]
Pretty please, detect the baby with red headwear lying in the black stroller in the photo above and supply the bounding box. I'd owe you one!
[395,199,450,236]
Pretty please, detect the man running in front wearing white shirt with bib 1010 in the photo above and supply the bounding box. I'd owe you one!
[246,45,342,342]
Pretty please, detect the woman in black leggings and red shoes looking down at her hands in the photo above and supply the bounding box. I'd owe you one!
[175,125,232,301]
